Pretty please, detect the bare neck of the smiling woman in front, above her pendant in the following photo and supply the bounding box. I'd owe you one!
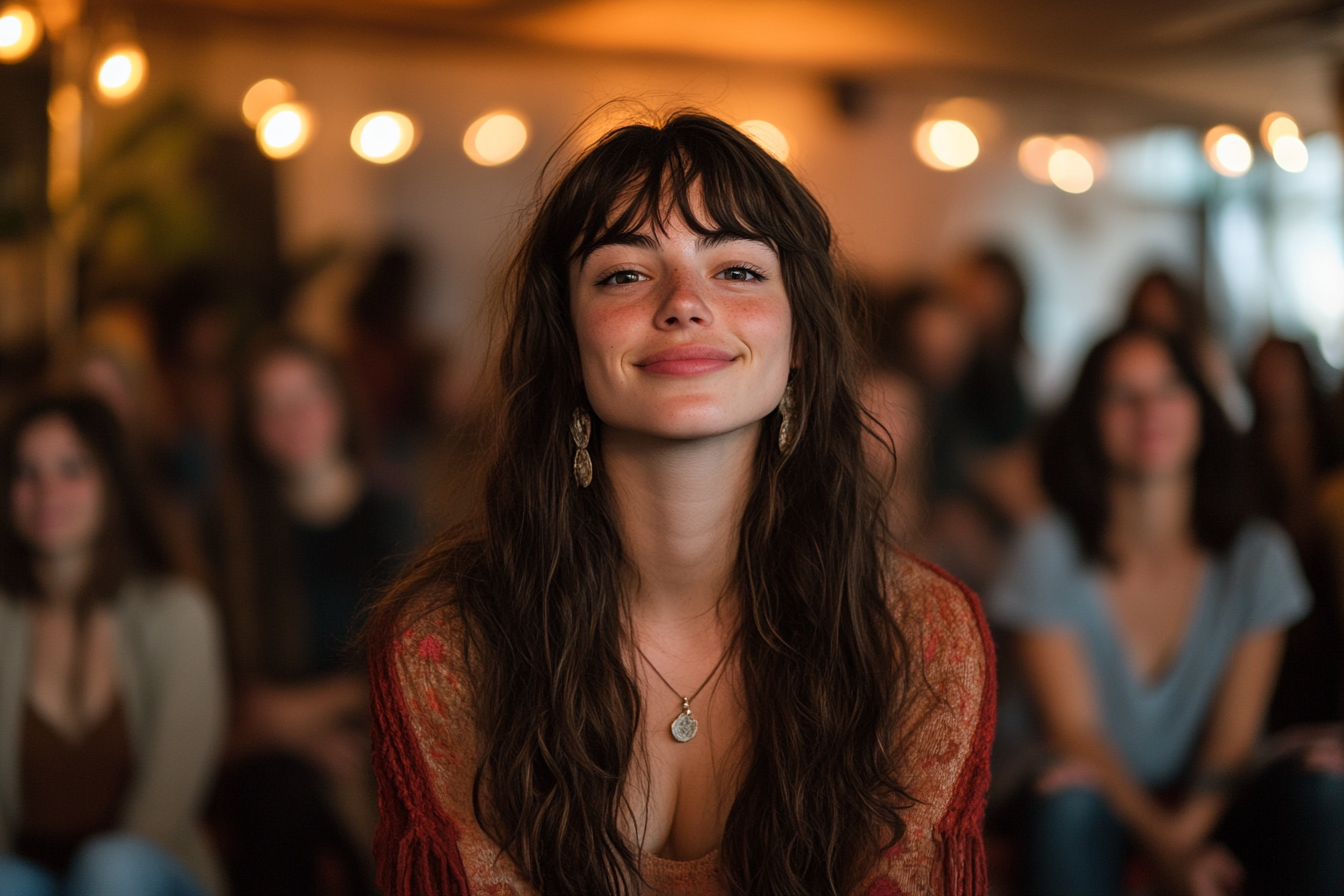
[599,424,759,625]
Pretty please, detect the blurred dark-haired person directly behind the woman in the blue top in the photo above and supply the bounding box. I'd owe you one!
[1124,269,1253,433]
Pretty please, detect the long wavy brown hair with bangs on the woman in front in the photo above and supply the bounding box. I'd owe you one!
[370,111,906,893]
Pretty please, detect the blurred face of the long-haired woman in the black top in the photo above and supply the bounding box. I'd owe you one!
[253,352,345,473]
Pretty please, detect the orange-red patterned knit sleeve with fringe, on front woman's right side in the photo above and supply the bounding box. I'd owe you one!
[866,555,995,896]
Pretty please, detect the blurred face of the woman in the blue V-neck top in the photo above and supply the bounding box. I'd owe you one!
[1097,337,1200,478]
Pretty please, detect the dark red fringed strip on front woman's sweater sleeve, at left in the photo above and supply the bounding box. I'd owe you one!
[370,631,470,896]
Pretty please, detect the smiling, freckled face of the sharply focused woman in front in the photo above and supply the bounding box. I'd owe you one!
[570,198,793,439]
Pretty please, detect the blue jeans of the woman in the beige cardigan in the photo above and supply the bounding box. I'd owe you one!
[0,834,204,896]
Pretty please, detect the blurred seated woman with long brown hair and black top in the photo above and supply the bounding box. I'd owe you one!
[205,334,413,895]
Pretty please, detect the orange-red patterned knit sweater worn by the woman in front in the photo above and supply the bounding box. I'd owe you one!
[371,555,995,896]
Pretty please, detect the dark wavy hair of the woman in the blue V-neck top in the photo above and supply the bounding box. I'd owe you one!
[1040,326,1251,563]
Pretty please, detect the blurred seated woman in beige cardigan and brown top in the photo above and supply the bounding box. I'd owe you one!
[0,396,224,896]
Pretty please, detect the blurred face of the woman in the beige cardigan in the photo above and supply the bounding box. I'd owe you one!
[9,415,103,557]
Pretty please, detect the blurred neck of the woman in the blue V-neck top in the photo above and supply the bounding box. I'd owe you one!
[1105,473,1195,563]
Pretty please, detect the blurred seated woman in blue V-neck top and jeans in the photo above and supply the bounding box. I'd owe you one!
[991,330,1344,896]
